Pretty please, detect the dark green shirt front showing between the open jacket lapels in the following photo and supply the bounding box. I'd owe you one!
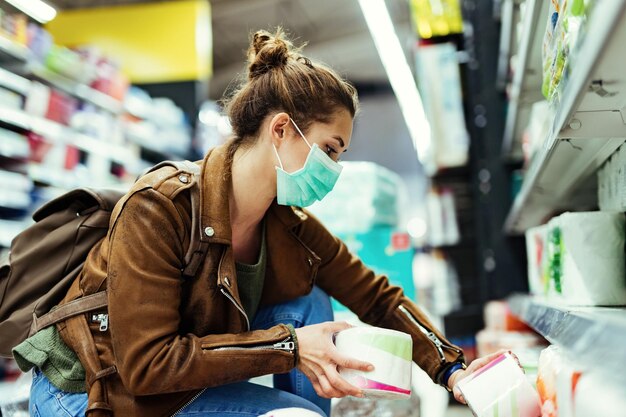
[235,222,267,322]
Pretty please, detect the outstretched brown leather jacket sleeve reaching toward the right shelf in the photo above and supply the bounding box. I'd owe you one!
[296,212,465,384]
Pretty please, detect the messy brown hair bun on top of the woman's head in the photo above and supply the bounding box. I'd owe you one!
[248,28,292,79]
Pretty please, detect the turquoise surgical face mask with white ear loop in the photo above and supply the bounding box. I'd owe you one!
[272,120,343,207]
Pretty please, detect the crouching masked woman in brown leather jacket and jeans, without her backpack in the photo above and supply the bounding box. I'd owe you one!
[23,30,487,417]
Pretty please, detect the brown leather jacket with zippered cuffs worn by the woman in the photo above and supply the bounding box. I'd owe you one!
[57,141,463,417]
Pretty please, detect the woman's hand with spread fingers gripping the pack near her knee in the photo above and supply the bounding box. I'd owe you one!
[296,321,374,398]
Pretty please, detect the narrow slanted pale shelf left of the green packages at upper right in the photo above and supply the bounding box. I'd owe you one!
[501,0,550,161]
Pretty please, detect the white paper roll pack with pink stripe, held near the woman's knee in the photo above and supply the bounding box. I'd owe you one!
[335,327,413,399]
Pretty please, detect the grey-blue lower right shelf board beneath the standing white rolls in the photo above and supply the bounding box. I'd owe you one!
[509,295,626,378]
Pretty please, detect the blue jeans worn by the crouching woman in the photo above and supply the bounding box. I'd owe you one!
[30,287,333,417]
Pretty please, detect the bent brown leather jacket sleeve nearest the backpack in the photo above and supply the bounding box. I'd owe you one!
[108,189,295,395]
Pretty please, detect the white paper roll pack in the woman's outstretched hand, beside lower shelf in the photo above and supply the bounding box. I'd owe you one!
[457,353,541,417]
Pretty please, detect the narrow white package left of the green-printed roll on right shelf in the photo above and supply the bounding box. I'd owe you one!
[526,225,549,295]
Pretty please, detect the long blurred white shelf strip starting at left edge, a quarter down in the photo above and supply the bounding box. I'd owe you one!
[0,107,136,164]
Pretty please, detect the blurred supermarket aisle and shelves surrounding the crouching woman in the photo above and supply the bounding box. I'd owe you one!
[0,0,626,417]
